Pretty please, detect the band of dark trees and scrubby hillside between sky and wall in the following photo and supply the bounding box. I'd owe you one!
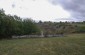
[0,9,85,39]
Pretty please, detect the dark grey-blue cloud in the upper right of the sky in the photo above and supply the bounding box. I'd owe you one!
[49,0,85,21]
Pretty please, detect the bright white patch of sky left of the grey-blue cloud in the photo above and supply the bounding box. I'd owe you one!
[0,0,71,21]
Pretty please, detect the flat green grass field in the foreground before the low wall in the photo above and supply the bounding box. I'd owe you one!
[0,34,85,55]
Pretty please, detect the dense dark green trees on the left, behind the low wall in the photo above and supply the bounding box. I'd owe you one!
[0,9,40,39]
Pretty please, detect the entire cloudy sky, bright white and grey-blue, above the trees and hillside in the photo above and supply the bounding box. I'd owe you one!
[0,0,85,21]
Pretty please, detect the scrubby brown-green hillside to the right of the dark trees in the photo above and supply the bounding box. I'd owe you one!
[38,21,85,35]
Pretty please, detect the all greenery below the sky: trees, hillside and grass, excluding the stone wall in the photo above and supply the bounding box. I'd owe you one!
[0,6,85,55]
